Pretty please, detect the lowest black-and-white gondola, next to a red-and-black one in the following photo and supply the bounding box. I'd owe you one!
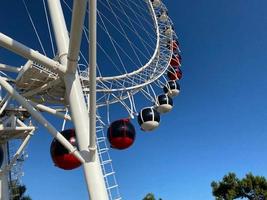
[138,107,160,131]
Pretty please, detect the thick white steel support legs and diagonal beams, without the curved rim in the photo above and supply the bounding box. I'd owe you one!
[0,0,108,200]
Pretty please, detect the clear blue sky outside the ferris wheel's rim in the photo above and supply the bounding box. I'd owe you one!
[0,0,267,200]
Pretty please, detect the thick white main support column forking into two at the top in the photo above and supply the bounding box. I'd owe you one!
[48,0,108,200]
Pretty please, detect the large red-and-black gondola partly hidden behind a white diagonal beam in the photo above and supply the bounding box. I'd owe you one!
[50,129,81,170]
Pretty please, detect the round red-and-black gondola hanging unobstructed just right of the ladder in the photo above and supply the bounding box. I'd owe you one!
[107,119,135,150]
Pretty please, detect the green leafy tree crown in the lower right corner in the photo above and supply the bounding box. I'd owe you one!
[211,173,267,200]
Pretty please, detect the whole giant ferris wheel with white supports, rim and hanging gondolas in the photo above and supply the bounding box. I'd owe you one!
[0,0,182,200]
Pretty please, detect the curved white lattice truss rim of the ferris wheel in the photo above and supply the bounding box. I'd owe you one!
[2,1,174,107]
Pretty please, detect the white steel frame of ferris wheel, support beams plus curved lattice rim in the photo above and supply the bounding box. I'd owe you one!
[0,0,179,200]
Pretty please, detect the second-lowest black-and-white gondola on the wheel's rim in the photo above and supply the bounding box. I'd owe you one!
[156,94,173,114]
